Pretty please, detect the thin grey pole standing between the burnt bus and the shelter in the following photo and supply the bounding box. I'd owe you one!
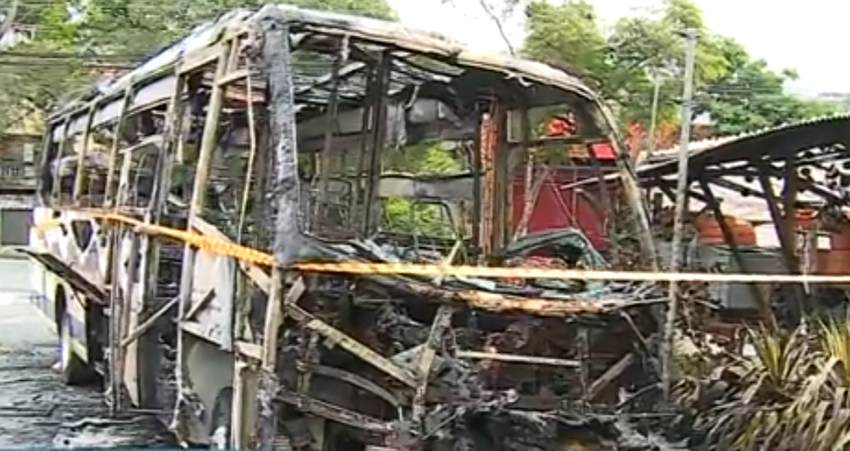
[661,29,697,403]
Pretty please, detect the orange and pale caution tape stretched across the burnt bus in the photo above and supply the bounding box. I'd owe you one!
[34,209,850,284]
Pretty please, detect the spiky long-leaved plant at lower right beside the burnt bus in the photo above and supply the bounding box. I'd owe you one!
[678,319,850,451]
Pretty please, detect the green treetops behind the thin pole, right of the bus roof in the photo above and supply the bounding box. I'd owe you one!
[523,0,835,142]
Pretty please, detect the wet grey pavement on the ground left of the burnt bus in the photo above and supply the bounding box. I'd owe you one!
[0,260,174,449]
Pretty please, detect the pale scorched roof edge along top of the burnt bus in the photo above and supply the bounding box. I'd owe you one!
[48,5,616,141]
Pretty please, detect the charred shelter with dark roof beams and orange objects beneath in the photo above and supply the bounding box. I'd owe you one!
[569,113,850,340]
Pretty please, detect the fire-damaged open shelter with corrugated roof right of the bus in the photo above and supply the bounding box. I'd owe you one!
[638,113,850,327]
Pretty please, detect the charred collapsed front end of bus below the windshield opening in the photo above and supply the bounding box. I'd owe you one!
[266,229,688,451]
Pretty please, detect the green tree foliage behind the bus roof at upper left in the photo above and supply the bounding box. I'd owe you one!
[0,0,395,130]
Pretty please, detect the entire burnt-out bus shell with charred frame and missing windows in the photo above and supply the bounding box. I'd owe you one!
[32,6,658,449]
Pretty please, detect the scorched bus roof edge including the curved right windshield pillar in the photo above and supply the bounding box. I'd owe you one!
[45,5,658,268]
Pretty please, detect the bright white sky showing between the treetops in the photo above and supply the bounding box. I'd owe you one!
[390,0,850,93]
